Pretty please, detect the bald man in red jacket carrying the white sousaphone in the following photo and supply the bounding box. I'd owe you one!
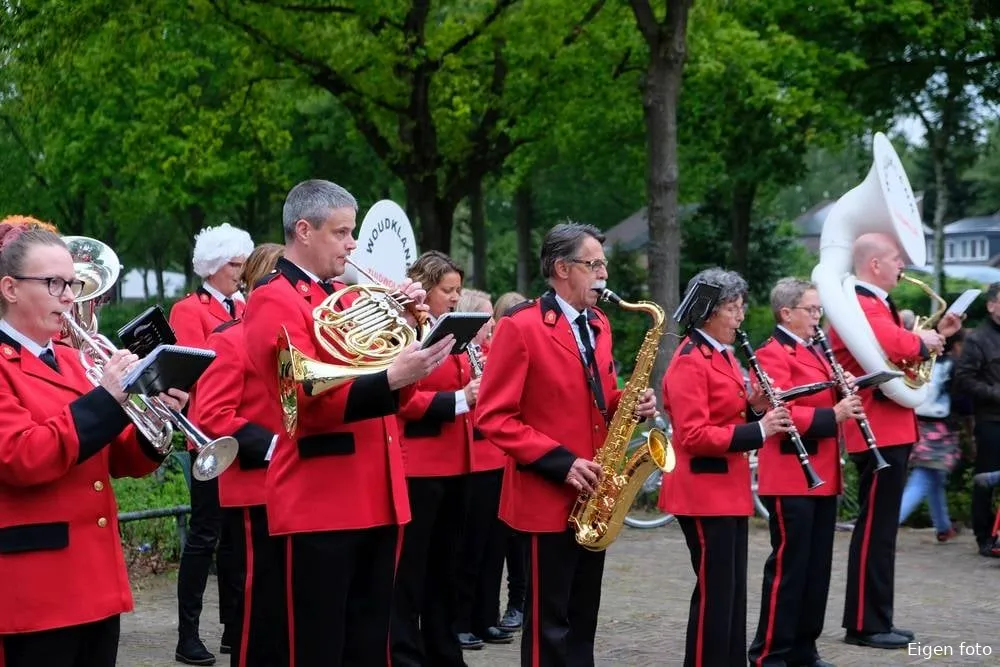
[830,234,962,648]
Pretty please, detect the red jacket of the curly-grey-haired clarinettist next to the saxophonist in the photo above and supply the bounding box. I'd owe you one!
[659,330,763,516]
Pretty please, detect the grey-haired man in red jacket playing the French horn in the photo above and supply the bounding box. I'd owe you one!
[243,180,455,667]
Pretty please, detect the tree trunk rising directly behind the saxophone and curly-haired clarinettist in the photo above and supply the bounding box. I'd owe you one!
[631,0,693,412]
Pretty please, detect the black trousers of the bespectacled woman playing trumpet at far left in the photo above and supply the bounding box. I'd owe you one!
[0,614,121,667]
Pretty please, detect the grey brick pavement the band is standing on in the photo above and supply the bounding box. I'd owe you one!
[118,520,1000,667]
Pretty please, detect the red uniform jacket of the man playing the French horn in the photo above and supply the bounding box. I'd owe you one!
[243,258,410,535]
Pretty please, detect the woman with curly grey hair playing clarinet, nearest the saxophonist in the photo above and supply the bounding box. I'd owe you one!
[659,269,801,667]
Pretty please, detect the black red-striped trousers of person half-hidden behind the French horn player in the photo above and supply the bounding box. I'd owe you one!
[222,505,288,667]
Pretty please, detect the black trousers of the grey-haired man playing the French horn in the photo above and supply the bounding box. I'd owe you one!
[285,526,402,667]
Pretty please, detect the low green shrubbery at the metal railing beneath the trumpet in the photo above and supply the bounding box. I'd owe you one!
[112,449,191,568]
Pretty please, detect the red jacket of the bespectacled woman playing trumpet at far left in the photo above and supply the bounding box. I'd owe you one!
[0,333,163,635]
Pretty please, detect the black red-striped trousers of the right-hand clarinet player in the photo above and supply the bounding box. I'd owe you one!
[748,496,837,667]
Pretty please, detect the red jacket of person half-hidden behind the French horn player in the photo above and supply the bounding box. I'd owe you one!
[196,320,282,507]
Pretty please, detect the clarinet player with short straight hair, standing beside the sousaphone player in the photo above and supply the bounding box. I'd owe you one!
[749,278,863,667]
